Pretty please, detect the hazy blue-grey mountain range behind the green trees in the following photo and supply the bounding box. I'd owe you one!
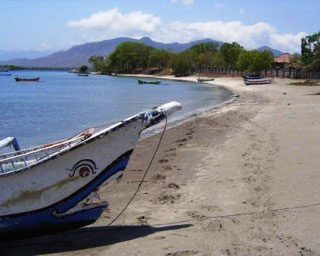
[0,37,281,68]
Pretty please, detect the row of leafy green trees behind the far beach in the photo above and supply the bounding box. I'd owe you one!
[89,32,320,74]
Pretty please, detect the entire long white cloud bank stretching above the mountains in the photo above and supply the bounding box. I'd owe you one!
[68,8,306,53]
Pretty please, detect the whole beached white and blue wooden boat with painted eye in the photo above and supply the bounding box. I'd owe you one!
[0,102,181,237]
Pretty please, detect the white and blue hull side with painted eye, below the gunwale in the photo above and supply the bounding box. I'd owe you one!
[0,119,144,235]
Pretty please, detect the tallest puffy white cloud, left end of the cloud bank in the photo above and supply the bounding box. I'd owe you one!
[67,8,161,33]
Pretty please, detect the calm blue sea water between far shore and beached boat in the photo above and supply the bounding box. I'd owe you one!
[0,71,231,148]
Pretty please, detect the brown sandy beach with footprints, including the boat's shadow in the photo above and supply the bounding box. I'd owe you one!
[0,77,320,256]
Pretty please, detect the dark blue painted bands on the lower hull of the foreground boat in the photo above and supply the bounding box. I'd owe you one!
[0,150,133,240]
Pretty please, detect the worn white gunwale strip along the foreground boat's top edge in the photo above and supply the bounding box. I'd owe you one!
[0,111,147,179]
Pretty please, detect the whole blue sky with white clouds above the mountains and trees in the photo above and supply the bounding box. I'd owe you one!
[0,0,320,53]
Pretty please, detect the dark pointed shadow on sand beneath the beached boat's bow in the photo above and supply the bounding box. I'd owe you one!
[0,224,192,256]
